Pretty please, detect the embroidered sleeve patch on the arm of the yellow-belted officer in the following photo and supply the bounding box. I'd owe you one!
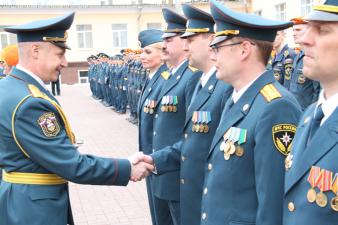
[38,112,60,137]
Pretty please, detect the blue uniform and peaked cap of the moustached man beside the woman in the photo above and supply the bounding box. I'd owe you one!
[153,8,201,225]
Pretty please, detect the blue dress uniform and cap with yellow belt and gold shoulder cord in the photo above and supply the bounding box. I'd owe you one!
[0,13,131,225]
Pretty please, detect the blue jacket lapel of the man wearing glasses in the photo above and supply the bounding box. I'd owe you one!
[209,71,275,156]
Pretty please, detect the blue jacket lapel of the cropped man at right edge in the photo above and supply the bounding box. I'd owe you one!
[285,106,338,193]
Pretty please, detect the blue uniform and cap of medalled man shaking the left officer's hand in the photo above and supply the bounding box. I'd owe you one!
[152,4,232,225]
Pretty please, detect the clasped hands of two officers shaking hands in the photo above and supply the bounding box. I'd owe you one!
[128,152,155,182]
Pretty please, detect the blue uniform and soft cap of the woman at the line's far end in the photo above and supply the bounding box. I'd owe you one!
[137,29,170,224]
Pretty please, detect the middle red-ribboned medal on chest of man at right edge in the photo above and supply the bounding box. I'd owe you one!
[316,169,333,207]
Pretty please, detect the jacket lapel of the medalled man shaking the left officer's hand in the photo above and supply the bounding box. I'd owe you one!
[184,72,217,126]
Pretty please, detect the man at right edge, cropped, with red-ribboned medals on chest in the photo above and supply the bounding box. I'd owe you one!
[283,0,338,225]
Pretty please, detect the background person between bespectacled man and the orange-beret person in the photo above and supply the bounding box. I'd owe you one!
[267,30,296,86]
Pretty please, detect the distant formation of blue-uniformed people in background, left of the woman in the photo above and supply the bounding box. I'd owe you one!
[87,49,148,124]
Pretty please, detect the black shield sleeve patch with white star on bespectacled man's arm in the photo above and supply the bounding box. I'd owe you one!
[272,124,297,156]
